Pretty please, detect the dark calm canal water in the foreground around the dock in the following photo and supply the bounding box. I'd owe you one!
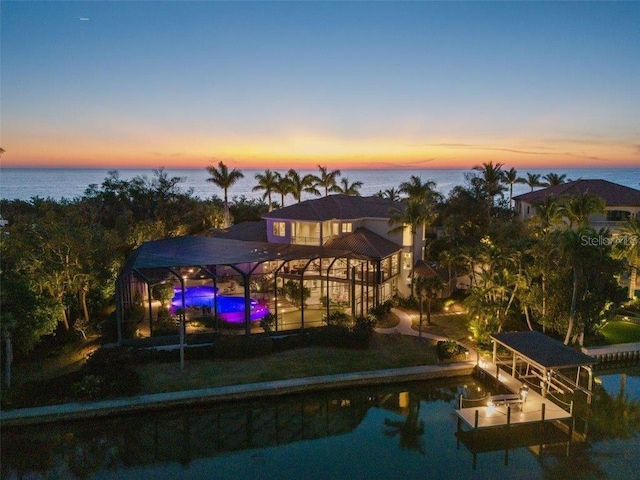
[1,371,640,480]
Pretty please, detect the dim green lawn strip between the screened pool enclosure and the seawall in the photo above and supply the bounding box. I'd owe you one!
[135,334,437,393]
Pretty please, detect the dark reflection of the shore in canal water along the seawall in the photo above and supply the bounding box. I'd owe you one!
[2,381,458,479]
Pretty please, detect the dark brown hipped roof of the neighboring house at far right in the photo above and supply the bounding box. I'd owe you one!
[513,180,640,207]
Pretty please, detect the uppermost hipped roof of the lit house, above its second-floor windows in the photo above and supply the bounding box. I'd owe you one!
[262,195,406,222]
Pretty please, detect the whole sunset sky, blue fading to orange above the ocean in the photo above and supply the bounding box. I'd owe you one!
[0,1,640,169]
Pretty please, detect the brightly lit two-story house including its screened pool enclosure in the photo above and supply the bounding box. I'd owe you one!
[117,195,425,335]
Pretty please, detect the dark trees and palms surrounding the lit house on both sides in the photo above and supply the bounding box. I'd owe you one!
[0,162,638,355]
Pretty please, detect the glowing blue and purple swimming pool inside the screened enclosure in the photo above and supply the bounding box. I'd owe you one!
[171,285,269,323]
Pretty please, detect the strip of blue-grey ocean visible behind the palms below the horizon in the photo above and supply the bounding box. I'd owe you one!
[0,168,640,205]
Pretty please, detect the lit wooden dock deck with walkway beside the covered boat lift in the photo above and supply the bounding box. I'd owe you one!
[456,361,572,430]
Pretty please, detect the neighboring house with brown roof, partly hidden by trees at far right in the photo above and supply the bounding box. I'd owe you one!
[513,180,640,231]
